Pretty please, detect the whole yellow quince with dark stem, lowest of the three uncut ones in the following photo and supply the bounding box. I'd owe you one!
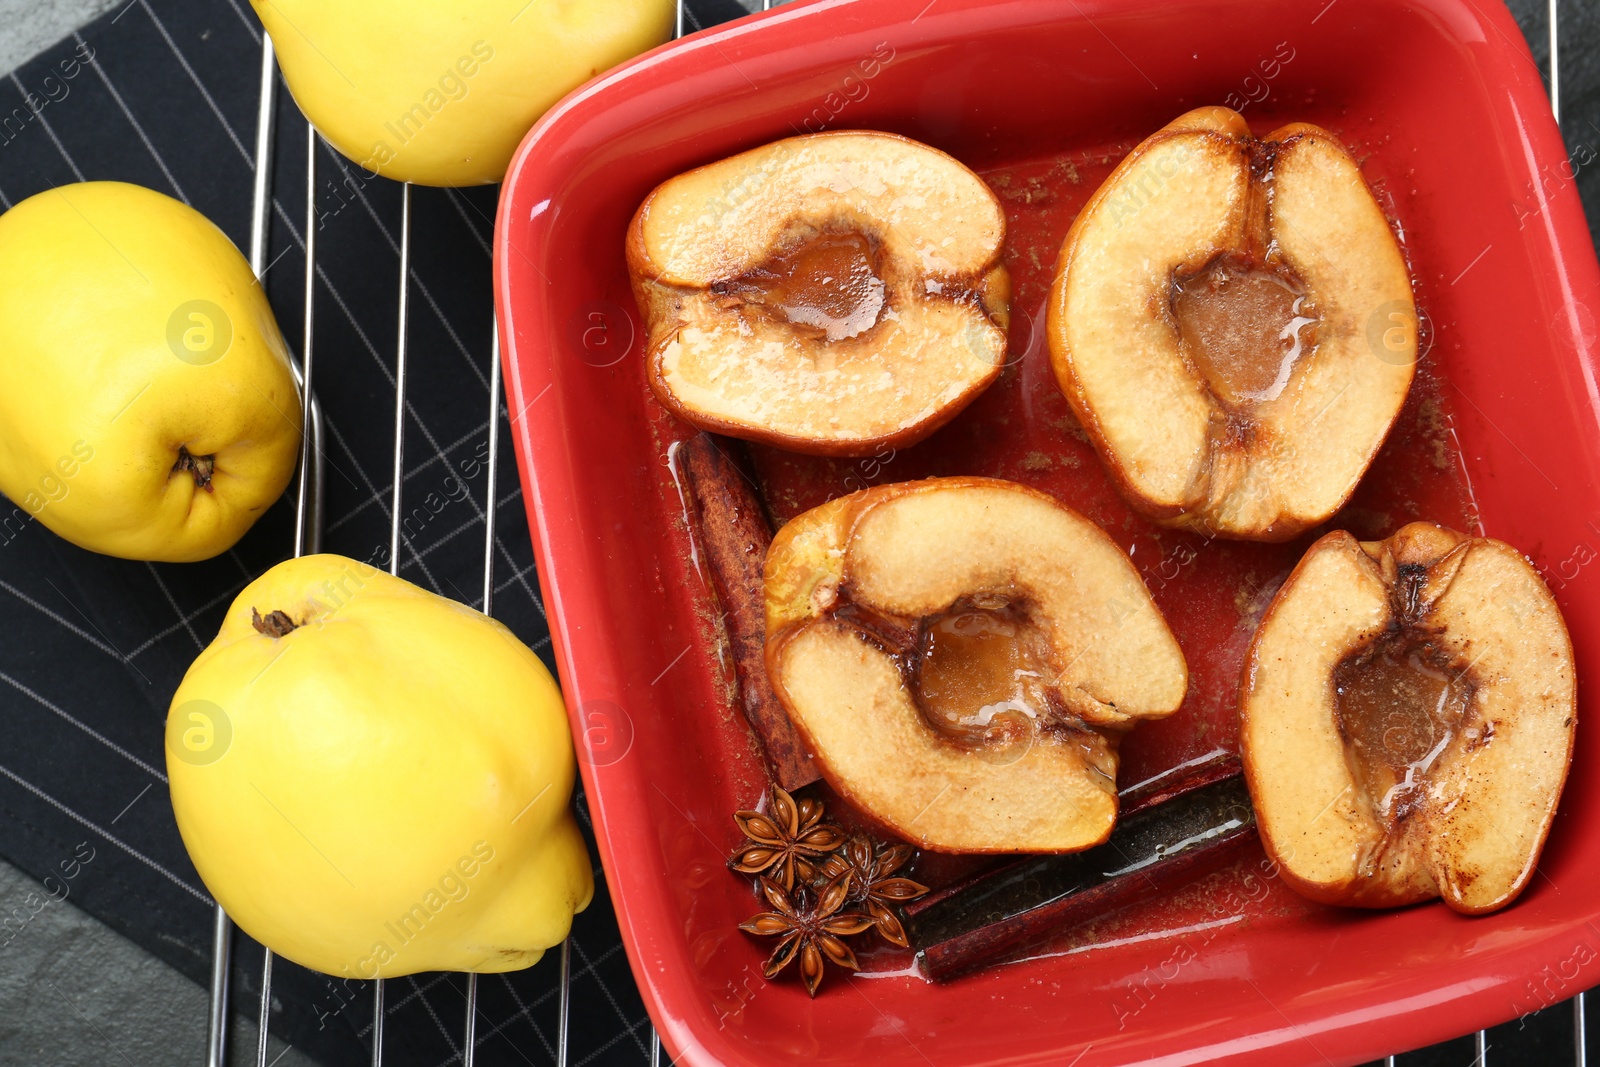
[166,555,594,977]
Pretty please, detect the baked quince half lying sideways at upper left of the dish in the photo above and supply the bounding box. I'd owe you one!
[627,131,1010,456]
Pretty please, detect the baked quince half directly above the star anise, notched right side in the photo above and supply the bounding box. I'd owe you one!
[765,478,1189,853]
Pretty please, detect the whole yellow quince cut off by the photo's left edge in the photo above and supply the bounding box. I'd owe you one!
[0,182,301,561]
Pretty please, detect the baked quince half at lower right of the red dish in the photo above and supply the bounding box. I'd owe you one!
[1240,523,1578,913]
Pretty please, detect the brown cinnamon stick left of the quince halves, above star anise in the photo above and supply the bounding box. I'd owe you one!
[678,434,821,792]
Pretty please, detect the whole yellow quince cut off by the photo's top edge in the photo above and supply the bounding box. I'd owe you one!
[259,0,677,186]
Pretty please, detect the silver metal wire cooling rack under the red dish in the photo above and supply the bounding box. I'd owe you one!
[206,0,1589,1067]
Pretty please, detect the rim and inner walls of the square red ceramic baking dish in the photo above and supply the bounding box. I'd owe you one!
[494,0,1600,1067]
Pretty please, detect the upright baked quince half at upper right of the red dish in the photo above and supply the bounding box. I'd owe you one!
[1048,107,1416,541]
